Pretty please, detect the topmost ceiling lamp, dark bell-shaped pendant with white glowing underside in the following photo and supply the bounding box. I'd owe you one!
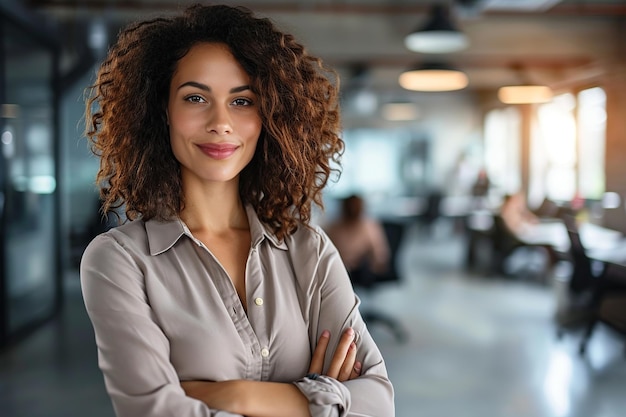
[404,4,469,54]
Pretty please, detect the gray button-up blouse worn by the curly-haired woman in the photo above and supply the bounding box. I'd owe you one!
[80,207,394,417]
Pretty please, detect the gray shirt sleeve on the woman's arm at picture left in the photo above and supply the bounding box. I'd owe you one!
[80,233,242,417]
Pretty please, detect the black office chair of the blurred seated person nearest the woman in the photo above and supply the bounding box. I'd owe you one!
[350,221,408,342]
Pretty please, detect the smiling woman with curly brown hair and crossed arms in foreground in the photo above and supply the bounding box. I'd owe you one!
[81,5,394,417]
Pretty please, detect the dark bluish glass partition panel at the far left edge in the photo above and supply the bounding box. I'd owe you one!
[0,10,62,346]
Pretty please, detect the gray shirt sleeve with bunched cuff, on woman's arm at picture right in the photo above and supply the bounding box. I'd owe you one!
[295,229,395,417]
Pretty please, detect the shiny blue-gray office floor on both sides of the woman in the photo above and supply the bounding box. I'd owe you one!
[0,219,626,417]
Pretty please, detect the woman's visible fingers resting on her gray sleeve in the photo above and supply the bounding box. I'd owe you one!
[309,327,361,382]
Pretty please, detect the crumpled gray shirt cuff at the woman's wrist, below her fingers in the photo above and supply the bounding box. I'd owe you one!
[294,375,350,417]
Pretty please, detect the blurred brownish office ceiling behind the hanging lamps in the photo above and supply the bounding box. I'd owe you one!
[22,0,626,107]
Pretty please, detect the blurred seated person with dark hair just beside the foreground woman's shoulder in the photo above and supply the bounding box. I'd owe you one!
[325,195,390,284]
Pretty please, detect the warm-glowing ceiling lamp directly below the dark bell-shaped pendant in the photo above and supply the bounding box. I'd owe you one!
[398,63,469,91]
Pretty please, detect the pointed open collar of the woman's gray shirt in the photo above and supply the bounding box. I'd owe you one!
[145,205,287,256]
